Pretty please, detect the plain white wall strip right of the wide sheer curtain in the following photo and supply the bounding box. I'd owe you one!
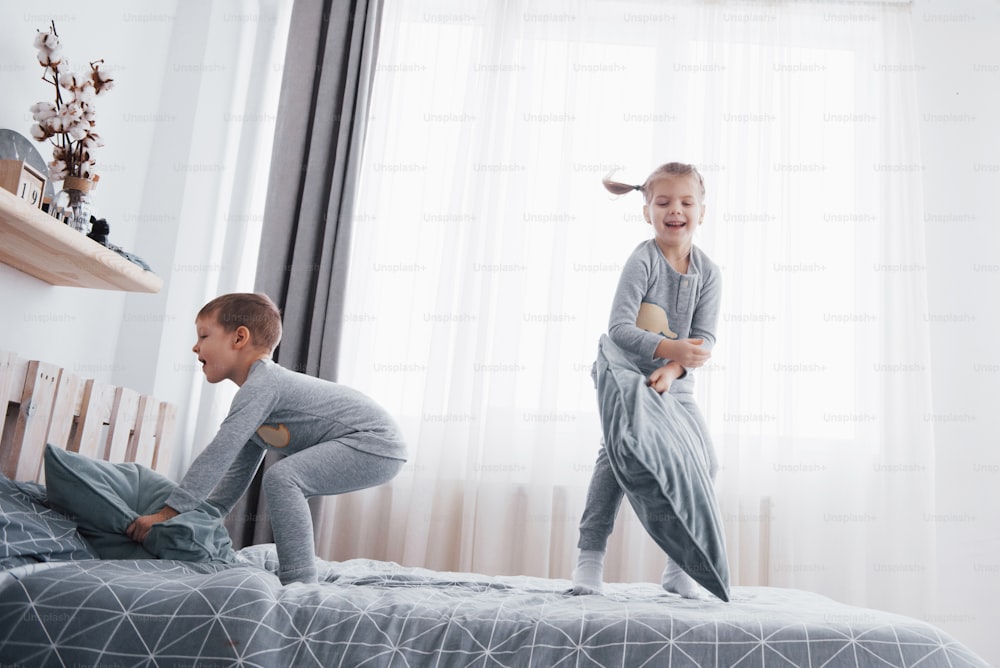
[914,0,1000,665]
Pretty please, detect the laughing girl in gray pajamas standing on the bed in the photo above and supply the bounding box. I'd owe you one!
[571,162,721,598]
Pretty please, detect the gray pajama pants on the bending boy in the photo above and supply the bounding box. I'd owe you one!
[263,434,406,584]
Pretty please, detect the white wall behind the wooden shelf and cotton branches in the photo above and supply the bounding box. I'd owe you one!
[0,1,174,380]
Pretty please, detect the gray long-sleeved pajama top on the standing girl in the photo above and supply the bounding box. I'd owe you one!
[608,239,722,393]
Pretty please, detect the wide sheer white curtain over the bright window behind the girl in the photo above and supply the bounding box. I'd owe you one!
[318,0,935,611]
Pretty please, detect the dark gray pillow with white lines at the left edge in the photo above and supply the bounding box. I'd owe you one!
[0,476,97,569]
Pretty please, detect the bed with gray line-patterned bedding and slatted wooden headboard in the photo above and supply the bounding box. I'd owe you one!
[0,355,987,668]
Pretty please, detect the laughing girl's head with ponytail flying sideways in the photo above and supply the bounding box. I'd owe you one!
[604,162,705,252]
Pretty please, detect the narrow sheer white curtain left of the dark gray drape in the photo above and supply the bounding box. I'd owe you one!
[160,0,291,479]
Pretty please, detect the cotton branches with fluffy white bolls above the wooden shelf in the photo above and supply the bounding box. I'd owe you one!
[31,22,114,187]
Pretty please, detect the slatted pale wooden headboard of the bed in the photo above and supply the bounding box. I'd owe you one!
[0,351,176,482]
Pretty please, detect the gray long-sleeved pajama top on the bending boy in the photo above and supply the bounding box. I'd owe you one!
[166,359,406,513]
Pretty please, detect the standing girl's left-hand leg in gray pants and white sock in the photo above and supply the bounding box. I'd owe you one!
[570,446,624,594]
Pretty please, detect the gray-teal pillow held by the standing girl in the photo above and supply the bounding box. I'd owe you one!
[595,335,729,601]
